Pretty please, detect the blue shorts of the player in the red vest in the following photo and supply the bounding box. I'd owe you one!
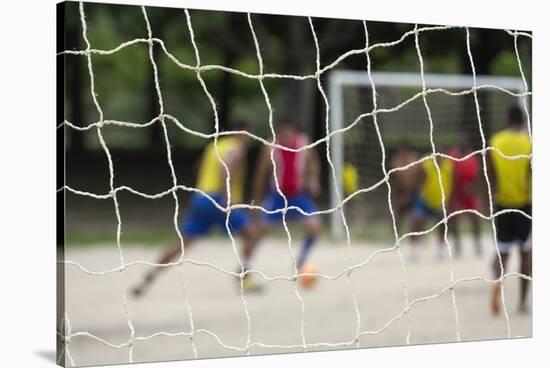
[263,191,317,222]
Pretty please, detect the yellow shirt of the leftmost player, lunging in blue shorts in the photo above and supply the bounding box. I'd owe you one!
[197,137,246,203]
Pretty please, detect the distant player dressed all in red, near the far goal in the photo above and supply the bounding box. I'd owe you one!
[449,139,482,256]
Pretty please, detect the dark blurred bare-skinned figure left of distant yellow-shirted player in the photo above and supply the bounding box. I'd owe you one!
[391,142,422,232]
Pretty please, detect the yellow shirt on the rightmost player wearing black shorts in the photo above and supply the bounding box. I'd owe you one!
[489,129,531,208]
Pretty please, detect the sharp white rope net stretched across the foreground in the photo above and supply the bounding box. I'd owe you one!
[58,3,532,366]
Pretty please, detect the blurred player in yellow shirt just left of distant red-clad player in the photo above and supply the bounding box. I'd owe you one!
[410,156,454,260]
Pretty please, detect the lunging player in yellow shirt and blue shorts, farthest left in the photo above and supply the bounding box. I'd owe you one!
[133,122,259,296]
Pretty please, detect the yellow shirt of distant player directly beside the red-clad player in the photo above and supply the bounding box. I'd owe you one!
[420,159,453,211]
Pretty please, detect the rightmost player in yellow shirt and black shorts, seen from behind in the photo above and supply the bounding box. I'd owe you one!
[489,106,532,314]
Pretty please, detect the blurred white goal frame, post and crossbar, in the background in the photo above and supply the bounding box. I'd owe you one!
[329,70,528,239]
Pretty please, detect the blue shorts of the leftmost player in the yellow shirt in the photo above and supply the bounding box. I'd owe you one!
[180,193,249,237]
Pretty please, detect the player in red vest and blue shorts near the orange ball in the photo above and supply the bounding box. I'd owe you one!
[254,118,321,278]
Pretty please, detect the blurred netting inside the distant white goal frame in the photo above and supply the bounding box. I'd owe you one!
[340,81,528,229]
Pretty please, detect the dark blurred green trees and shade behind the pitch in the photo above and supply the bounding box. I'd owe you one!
[57,2,531,243]
